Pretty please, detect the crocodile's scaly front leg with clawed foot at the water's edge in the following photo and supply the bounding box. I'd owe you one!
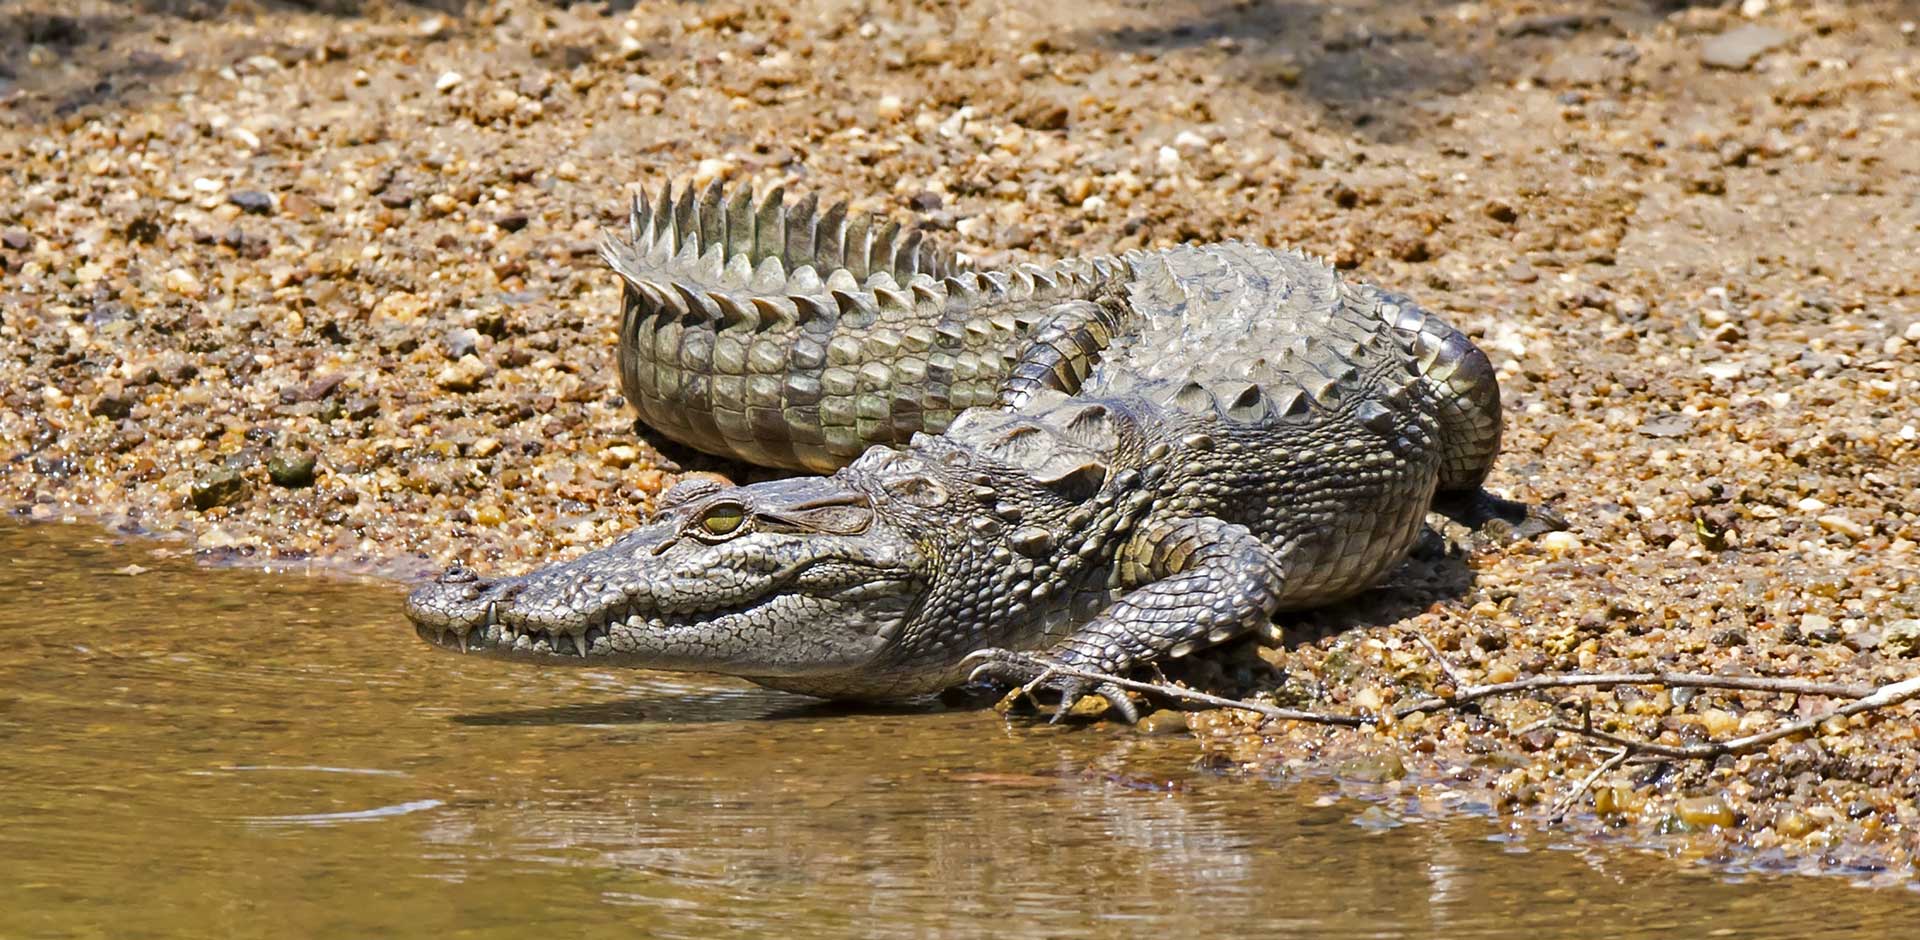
[970,516,1286,721]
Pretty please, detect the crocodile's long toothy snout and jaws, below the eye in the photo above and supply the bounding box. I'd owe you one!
[407,524,920,677]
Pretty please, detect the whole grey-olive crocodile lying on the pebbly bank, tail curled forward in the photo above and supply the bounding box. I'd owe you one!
[407,184,1536,717]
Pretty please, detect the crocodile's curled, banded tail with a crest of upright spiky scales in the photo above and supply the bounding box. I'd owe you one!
[601,184,1121,472]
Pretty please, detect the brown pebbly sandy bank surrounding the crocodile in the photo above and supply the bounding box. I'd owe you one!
[0,0,1920,881]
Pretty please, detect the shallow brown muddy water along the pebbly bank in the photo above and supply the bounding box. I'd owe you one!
[0,524,1916,940]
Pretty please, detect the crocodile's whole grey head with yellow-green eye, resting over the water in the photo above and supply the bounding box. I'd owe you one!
[407,472,927,687]
